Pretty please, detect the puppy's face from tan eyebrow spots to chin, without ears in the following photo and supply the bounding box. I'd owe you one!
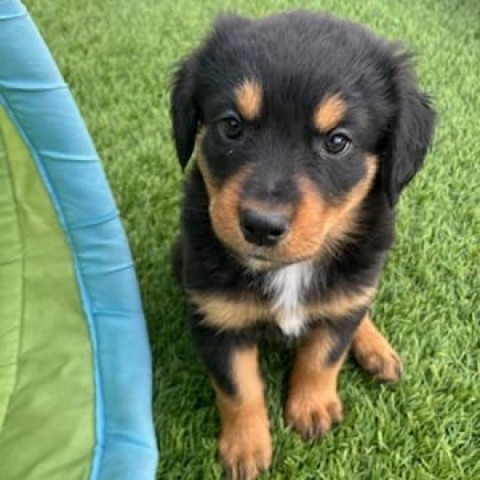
[198,83,377,268]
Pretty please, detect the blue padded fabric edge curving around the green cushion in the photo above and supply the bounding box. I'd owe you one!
[0,0,158,480]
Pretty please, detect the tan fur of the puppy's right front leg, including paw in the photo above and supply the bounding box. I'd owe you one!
[285,328,344,438]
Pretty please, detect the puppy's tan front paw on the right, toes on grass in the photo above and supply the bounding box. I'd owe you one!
[285,388,343,440]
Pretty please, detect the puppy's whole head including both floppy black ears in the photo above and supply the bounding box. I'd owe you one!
[172,12,434,268]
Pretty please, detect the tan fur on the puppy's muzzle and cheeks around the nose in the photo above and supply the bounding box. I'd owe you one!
[197,120,378,269]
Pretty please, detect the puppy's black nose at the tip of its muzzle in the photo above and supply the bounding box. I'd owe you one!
[240,209,290,247]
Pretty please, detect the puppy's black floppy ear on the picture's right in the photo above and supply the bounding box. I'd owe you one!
[382,54,435,207]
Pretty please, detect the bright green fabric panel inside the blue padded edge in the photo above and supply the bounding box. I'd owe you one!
[0,108,95,480]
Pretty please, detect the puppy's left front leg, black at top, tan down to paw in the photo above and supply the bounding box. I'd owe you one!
[193,319,272,480]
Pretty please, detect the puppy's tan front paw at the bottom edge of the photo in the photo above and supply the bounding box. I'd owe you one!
[218,418,272,480]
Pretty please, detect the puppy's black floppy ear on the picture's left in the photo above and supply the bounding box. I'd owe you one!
[170,57,199,169]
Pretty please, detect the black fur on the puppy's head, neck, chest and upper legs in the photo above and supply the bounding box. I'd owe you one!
[171,12,434,406]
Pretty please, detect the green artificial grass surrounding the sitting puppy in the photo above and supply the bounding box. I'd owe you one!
[26,0,480,480]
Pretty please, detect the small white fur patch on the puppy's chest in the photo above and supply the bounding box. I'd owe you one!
[265,262,313,336]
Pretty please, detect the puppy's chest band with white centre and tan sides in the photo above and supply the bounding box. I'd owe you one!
[189,263,376,336]
